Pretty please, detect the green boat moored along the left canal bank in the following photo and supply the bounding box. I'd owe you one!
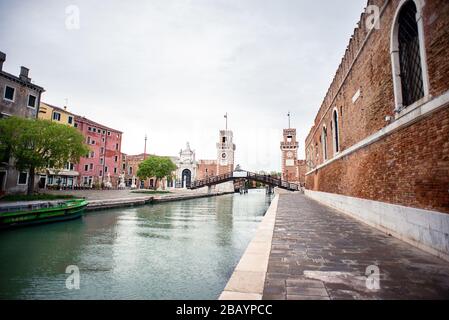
[0,199,87,229]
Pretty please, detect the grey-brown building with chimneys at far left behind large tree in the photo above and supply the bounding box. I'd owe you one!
[0,52,44,194]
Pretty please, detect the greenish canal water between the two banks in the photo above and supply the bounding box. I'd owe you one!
[0,190,271,299]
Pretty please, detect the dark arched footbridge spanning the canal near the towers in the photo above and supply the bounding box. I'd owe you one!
[189,171,301,191]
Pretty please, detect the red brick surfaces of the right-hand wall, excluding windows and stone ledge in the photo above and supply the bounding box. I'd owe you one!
[306,0,449,213]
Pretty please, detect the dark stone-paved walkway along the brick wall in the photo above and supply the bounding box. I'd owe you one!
[263,194,449,300]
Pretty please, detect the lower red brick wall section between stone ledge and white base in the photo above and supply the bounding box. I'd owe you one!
[306,107,449,213]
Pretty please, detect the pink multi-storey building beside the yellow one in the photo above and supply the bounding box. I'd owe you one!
[75,116,123,188]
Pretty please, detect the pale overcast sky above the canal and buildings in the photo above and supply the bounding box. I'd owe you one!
[0,0,366,171]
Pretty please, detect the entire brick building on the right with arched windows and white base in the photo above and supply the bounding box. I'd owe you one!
[306,0,449,257]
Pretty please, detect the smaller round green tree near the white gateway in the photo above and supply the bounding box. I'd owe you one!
[137,156,176,190]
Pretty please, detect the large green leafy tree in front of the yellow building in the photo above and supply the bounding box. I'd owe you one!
[0,117,89,195]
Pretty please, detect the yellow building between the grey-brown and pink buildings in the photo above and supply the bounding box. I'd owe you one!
[38,102,79,189]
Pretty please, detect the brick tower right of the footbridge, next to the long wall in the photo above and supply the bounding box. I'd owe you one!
[281,129,299,183]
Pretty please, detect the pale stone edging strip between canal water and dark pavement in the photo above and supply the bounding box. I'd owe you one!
[218,194,279,300]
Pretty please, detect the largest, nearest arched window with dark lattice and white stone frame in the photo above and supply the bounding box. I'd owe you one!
[391,0,429,111]
